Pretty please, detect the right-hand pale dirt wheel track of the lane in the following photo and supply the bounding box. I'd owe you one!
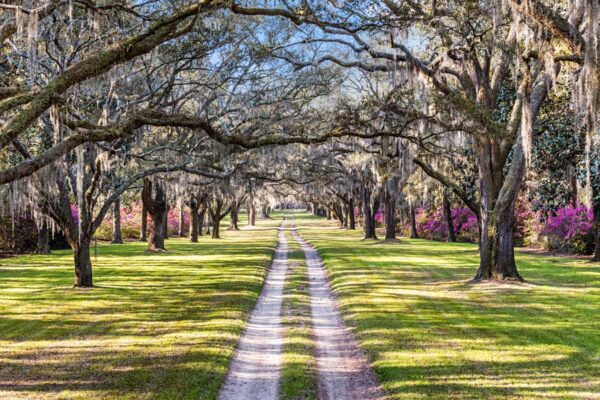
[292,229,385,400]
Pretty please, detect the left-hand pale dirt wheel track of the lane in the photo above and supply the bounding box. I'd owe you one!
[218,226,288,400]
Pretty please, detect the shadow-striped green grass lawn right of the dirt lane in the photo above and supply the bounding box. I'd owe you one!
[298,214,600,399]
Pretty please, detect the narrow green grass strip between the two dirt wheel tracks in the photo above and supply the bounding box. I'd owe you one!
[281,227,317,400]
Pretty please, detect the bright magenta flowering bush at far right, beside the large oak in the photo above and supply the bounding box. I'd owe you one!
[541,206,594,254]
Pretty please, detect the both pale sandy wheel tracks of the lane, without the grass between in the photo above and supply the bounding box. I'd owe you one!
[218,227,385,400]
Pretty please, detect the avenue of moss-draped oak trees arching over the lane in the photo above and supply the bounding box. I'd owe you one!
[0,0,600,287]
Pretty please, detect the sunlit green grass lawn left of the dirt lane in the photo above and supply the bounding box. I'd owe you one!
[0,217,278,400]
